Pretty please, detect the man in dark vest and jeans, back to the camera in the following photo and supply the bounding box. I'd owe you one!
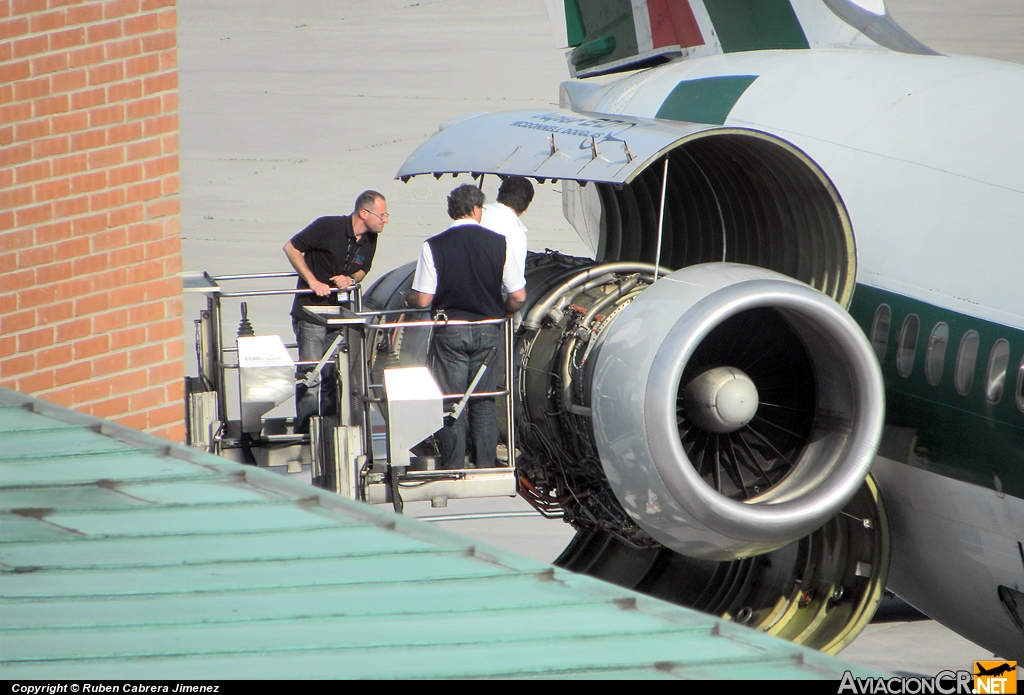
[406,184,526,468]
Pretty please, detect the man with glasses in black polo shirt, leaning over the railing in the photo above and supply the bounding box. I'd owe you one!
[285,190,388,432]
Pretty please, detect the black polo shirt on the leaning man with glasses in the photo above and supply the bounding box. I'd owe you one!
[292,215,377,320]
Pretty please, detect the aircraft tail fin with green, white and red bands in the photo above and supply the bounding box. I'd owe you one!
[545,0,935,77]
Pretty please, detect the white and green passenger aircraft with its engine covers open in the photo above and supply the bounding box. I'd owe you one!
[385,0,1024,660]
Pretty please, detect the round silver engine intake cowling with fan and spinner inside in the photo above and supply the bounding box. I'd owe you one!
[587,263,884,560]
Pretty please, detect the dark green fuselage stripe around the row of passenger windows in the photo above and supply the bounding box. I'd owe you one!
[850,285,1024,498]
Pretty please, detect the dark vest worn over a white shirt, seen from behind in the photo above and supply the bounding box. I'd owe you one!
[427,224,505,320]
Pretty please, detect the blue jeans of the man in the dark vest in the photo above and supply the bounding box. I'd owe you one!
[430,325,502,468]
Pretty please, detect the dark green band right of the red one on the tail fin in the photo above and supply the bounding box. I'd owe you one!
[705,0,810,53]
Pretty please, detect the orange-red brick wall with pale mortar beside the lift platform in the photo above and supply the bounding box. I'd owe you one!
[0,0,184,441]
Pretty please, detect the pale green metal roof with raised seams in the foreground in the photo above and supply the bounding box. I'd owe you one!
[0,389,880,680]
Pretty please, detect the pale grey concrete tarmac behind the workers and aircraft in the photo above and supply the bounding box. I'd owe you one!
[177,0,1024,676]
